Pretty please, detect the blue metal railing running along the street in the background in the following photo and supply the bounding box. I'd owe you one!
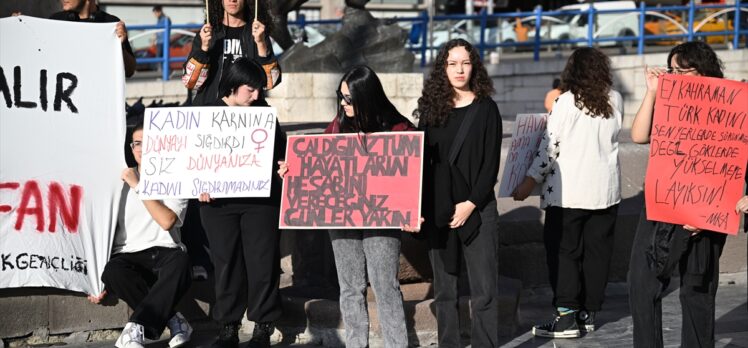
[128,0,748,80]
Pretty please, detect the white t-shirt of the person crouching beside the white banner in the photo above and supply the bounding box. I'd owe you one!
[112,184,187,254]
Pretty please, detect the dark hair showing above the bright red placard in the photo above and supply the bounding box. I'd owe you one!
[667,41,724,78]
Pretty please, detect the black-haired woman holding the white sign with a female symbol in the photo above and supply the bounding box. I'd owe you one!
[199,58,286,347]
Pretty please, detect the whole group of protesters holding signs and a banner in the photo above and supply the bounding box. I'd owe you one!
[33,0,748,348]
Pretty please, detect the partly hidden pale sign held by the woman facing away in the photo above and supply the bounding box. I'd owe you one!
[499,114,548,197]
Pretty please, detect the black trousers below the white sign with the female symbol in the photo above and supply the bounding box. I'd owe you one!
[200,200,282,324]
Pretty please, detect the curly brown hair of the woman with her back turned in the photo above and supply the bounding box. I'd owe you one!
[561,47,613,118]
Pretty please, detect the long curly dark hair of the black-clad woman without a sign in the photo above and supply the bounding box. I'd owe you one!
[413,39,495,127]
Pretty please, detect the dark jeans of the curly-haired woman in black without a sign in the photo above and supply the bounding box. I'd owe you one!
[429,201,499,348]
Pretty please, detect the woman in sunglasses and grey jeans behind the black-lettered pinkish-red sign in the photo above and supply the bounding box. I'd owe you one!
[278,66,415,348]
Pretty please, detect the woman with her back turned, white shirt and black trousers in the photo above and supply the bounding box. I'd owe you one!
[512,47,623,338]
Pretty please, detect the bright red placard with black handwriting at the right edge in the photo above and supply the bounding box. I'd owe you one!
[644,75,748,234]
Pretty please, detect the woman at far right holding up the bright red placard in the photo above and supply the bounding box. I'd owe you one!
[628,42,728,348]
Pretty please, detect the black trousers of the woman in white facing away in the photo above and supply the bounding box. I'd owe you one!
[543,204,618,311]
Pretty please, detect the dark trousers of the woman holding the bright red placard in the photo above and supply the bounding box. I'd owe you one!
[628,219,726,348]
